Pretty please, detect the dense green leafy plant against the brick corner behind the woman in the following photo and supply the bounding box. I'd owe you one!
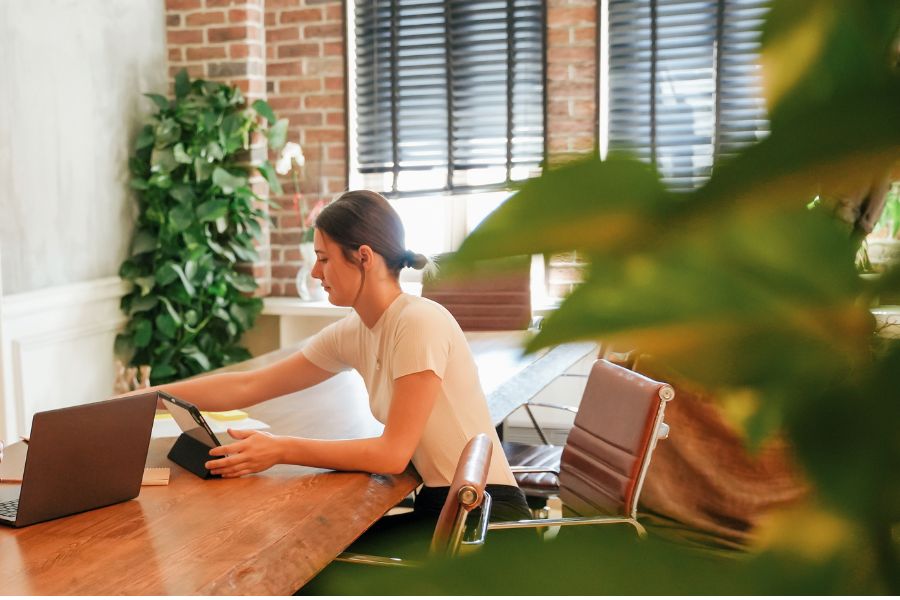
[116,71,287,383]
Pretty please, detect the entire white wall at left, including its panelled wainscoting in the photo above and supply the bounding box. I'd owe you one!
[0,0,168,439]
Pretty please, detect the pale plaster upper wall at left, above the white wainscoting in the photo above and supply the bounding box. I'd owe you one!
[0,0,167,294]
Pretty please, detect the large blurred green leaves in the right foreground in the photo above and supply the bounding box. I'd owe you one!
[336,0,900,594]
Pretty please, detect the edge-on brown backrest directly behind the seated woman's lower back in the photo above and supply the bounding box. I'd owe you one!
[430,433,493,556]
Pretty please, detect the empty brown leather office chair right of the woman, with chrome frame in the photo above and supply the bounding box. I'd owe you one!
[488,359,675,535]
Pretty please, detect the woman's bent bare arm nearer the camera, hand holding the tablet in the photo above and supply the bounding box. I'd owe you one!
[206,371,441,477]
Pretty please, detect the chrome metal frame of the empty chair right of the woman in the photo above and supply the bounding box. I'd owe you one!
[488,366,675,537]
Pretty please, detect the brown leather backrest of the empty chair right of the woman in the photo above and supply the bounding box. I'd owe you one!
[559,359,675,519]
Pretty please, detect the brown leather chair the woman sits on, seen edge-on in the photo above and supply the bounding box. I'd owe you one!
[335,433,493,567]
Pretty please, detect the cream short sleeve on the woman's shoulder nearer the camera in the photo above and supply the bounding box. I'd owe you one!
[391,304,453,379]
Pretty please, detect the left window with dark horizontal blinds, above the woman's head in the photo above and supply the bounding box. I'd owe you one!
[348,0,546,197]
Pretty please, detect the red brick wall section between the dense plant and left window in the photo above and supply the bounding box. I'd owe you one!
[265,0,347,296]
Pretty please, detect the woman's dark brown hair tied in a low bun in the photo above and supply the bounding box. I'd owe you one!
[316,190,428,275]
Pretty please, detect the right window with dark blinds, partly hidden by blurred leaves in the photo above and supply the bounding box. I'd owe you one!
[600,0,768,190]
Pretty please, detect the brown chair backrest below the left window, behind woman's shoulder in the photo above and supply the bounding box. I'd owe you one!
[422,257,531,331]
